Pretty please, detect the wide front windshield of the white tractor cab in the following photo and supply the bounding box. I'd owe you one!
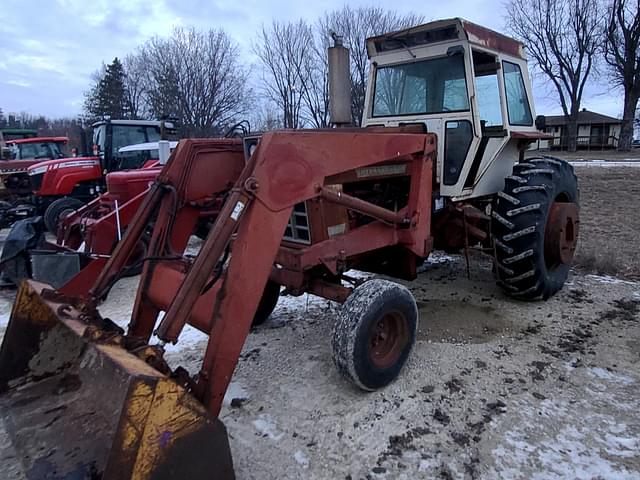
[373,55,469,117]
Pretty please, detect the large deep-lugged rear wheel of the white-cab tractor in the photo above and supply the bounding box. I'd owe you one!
[492,156,579,300]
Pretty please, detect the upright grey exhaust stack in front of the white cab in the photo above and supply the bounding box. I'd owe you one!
[328,32,351,127]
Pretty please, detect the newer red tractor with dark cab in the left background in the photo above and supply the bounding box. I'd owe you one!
[28,120,174,233]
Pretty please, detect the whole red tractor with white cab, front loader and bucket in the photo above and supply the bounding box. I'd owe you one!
[0,19,578,479]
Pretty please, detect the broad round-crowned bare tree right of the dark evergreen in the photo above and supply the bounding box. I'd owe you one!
[137,28,251,137]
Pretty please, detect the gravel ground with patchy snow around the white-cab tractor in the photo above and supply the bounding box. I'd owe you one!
[0,160,640,480]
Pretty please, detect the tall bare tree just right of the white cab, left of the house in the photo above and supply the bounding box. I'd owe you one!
[507,0,602,151]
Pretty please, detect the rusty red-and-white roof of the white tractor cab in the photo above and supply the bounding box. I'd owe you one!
[367,18,527,60]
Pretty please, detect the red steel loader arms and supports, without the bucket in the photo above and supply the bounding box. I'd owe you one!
[92,130,435,415]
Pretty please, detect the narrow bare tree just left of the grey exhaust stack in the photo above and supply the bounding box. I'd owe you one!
[254,20,314,128]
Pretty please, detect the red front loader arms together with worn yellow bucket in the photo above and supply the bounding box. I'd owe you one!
[0,127,435,479]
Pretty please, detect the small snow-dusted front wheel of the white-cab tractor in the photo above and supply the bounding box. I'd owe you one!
[332,279,418,391]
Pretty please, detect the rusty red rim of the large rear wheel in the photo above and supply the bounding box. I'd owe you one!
[544,201,580,269]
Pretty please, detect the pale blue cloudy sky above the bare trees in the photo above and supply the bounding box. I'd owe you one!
[0,0,622,117]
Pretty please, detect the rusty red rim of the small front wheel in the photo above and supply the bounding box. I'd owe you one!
[369,312,409,368]
